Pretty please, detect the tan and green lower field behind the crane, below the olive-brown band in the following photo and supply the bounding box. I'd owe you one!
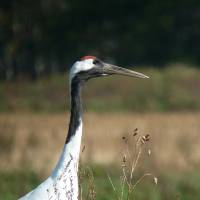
[0,112,200,200]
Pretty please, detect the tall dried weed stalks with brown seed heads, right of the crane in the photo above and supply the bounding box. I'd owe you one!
[107,128,158,200]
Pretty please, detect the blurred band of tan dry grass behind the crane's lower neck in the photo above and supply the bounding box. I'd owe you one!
[0,113,200,174]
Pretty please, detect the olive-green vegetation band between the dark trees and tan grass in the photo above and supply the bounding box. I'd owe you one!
[0,64,200,112]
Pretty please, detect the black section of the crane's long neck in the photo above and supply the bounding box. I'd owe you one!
[65,75,83,144]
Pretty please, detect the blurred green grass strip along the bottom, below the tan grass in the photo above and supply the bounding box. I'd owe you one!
[0,166,200,200]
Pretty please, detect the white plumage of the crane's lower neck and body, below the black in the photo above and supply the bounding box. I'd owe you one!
[20,122,82,200]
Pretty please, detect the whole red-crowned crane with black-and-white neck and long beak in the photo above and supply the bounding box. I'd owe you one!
[21,56,148,200]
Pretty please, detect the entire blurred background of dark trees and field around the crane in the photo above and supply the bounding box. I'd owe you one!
[0,0,200,200]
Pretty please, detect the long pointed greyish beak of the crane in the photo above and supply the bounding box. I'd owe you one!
[103,63,149,78]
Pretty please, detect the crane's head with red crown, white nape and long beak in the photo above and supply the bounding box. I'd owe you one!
[70,56,149,81]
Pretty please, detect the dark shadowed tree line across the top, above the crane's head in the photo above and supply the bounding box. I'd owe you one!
[0,0,200,80]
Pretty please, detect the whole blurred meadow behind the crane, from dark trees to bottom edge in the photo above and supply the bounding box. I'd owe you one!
[0,64,200,200]
